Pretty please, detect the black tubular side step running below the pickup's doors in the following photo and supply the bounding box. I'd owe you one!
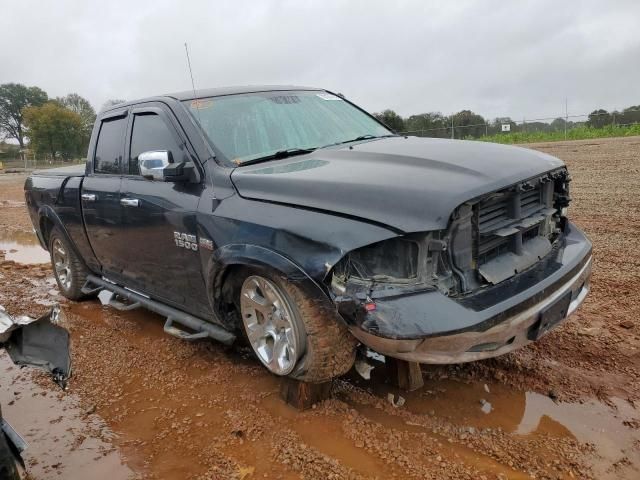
[83,275,236,345]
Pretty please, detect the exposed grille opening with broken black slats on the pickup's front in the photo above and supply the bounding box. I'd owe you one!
[450,168,571,293]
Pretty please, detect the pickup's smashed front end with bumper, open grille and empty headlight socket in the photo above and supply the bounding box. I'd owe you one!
[329,168,591,363]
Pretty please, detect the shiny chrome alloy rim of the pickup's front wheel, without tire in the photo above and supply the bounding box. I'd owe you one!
[240,275,304,375]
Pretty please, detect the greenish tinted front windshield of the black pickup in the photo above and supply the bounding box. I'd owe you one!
[184,90,392,164]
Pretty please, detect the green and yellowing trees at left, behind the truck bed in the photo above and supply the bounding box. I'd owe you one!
[0,83,123,161]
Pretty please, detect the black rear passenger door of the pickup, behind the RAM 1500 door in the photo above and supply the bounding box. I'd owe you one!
[80,110,128,280]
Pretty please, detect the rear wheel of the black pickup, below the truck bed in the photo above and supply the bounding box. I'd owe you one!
[49,227,89,300]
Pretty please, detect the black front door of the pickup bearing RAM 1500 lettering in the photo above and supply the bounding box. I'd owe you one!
[120,104,209,314]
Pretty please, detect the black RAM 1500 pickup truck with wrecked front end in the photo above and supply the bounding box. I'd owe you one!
[25,86,591,382]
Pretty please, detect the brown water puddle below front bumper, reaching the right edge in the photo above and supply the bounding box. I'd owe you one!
[352,368,640,479]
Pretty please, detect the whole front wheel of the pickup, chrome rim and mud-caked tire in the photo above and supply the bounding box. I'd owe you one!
[239,273,357,383]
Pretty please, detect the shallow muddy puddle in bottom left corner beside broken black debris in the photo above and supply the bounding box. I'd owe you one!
[0,351,133,480]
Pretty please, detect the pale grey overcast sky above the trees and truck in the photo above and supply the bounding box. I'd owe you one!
[0,0,640,120]
